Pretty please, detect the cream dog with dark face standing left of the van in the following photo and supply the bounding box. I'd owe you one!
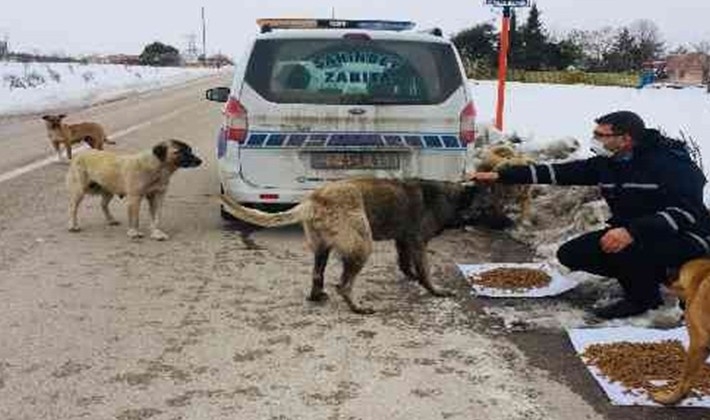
[66,140,202,241]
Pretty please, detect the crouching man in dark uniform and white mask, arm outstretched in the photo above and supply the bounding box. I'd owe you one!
[470,111,710,319]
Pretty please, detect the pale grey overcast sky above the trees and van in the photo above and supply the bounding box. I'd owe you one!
[0,0,710,55]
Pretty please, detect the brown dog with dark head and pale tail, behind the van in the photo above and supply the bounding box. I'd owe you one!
[222,178,510,314]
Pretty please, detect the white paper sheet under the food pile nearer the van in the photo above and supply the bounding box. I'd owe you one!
[457,262,578,298]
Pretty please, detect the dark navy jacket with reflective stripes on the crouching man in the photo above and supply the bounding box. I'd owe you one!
[499,129,710,253]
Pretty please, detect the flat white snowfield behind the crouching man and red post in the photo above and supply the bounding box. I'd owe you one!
[471,81,710,168]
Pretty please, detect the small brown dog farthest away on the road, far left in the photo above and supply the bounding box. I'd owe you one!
[42,114,116,160]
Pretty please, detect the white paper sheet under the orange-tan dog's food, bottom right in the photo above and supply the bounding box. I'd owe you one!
[567,327,710,407]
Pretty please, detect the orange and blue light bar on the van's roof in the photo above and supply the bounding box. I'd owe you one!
[256,19,416,32]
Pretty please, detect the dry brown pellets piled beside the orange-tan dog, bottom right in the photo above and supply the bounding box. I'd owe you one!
[582,340,710,395]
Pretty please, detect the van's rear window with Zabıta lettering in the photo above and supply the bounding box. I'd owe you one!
[246,39,463,105]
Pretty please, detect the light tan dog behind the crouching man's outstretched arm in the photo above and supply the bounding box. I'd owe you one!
[476,144,535,220]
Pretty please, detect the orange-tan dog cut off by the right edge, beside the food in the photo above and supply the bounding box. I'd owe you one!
[652,258,710,404]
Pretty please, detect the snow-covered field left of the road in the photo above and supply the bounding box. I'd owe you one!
[0,62,224,116]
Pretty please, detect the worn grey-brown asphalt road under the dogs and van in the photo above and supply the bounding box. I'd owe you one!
[0,74,707,420]
